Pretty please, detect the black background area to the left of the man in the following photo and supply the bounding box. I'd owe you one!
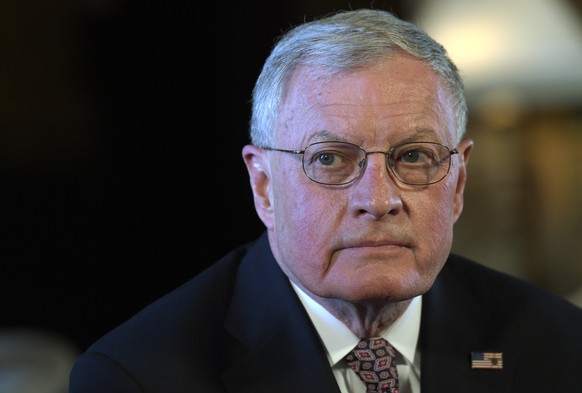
[0,0,407,349]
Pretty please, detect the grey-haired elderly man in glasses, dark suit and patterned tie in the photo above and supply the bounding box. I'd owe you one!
[70,9,582,393]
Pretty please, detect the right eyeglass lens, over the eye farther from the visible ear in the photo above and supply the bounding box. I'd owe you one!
[389,142,451,185]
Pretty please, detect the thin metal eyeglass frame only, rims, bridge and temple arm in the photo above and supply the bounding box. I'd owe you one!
[262,141,459,186]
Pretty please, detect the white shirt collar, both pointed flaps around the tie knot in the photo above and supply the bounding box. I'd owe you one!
[291,282,422,366]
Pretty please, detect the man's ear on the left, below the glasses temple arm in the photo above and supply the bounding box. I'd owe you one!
[242,145,274,229]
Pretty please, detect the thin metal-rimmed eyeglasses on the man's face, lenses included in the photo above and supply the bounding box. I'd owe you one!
[263,142,459,186]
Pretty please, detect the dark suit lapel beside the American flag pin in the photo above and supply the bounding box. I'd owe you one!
[419,261,512,393]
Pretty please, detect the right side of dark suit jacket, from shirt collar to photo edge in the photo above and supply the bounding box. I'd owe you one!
[420,255,582,392]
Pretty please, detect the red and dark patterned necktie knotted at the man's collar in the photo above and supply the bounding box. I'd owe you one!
[346,337,398,393]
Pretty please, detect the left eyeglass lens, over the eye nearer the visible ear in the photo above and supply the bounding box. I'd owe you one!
[303,142,366,185]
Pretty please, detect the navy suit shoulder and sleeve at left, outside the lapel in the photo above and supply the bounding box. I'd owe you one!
[69,236,272,391]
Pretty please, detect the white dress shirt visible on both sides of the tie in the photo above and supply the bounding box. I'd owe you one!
[291,283,422,393]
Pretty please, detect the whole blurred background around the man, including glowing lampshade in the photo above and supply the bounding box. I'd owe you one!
[0,0,582,393]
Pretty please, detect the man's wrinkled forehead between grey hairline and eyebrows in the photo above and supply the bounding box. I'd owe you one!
[275,56,454,143]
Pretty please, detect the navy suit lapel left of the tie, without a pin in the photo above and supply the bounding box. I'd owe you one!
[223,236,339,393]
